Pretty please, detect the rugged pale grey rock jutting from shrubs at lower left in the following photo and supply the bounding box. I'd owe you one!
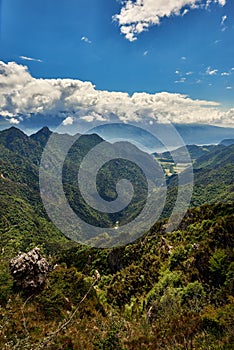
[10,248,50,292]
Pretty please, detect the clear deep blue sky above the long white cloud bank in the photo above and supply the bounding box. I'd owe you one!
[0,0,234,129]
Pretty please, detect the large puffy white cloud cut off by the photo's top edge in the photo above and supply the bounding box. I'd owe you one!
[113,0,226,41]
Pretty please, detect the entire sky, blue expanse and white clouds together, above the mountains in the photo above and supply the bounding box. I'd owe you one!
[0,0,234,129]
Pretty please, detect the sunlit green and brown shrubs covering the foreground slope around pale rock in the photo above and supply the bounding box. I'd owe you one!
[0,204,234,349]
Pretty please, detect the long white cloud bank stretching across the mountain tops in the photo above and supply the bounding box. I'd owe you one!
[0,62,234,125]
